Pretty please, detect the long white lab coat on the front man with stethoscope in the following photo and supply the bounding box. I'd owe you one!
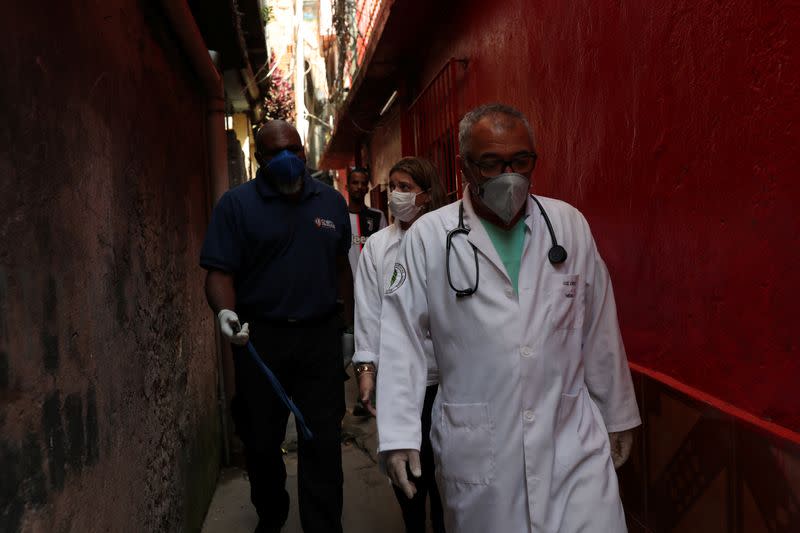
[377,194,641,533]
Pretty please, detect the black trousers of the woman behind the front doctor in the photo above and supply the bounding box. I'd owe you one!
[392,385,444,533]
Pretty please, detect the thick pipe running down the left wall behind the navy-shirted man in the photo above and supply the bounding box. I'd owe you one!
[156,0,233,464]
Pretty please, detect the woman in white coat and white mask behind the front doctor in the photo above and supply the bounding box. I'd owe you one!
[353,157,445,533]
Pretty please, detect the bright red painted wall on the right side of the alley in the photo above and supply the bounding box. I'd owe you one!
[396,0,800,430]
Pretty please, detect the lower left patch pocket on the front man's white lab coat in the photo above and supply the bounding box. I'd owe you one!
[439,403,494,485]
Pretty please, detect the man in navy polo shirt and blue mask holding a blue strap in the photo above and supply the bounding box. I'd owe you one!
[200,120,353,533]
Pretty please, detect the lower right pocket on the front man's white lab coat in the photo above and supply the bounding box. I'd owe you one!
[555,387,608,471]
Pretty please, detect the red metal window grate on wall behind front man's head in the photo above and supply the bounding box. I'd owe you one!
[403,59,467,201]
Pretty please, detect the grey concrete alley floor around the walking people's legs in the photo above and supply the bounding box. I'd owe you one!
[202,372,416,533]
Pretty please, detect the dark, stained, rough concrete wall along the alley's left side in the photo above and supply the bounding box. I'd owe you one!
[0,0,220,533]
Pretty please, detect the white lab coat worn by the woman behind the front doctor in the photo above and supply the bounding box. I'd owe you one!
[353,222,438,385]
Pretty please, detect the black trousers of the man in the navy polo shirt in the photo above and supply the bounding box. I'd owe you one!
[232,317,345,533]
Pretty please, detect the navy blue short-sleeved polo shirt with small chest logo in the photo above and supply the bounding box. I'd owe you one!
[200,174,350,321]
